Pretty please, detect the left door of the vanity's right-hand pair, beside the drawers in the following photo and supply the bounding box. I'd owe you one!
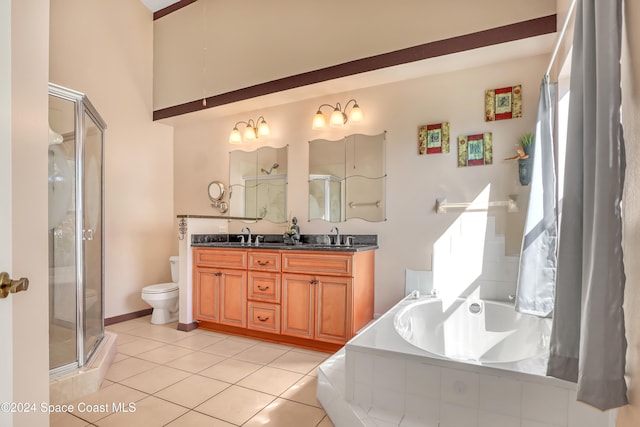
[281,274,315,339]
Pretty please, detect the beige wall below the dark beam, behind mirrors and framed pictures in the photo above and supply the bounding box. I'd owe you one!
[174,52,547,313]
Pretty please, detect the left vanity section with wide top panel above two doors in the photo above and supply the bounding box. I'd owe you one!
[193,248,247,328]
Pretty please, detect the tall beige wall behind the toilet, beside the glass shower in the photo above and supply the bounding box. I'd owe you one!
[49,0,177,317]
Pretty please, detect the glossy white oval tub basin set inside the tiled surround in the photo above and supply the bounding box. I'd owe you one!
[394,298,551,364]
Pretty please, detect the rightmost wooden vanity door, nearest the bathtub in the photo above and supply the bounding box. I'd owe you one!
[314,276,353,343]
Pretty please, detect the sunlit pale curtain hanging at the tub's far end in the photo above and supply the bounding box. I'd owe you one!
[516,76,558,317]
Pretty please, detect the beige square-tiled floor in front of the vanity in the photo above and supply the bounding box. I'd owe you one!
[50,316,333,427]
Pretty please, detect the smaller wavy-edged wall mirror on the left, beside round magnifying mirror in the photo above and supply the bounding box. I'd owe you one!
[229,146,288,223]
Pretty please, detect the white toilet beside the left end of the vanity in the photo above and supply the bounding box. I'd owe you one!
[142,256,180,325]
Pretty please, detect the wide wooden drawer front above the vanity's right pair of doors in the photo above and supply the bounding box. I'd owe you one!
[282,252,353,276]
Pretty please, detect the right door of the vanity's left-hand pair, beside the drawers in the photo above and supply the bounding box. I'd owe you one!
[219,269,247,328]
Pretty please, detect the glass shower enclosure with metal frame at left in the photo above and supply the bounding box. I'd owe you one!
[48,83,106,375]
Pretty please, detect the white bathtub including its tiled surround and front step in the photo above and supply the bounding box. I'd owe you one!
[317,296,616,427]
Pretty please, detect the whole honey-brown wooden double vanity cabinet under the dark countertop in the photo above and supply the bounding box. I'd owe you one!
[193,248,375,351]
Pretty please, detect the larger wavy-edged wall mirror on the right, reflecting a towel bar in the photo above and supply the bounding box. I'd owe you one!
[309,132,387,222]
